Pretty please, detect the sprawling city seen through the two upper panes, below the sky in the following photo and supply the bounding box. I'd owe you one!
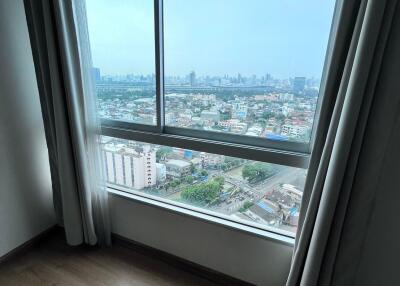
[95,69,319,142]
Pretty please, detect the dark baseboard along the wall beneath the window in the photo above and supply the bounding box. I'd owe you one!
[112,234,253,286]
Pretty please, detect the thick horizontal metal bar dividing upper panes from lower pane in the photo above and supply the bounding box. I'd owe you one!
[102,125,309,168]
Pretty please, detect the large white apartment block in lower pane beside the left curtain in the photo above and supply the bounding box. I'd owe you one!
[102,143,157,190]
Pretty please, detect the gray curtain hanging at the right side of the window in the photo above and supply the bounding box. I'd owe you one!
[287,0,400,286]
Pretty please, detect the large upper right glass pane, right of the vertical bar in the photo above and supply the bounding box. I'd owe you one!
[164,0,335,142]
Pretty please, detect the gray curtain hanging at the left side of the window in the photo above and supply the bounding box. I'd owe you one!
[24,0,110,245]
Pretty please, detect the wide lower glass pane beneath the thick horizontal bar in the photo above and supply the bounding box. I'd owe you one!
[102,137,306,234]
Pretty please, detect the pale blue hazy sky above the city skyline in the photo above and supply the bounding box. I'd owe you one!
[86,0,335,78]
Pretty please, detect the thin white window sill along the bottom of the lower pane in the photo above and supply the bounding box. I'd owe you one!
[107,187,295,246]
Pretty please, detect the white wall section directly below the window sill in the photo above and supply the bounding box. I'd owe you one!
[111,195,292,285]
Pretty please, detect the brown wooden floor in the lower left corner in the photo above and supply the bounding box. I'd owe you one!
[0,231,217,286]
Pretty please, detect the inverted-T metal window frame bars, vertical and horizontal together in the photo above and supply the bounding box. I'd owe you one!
[101,0,312,169]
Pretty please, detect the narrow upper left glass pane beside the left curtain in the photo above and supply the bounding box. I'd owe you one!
[86,0,157,125]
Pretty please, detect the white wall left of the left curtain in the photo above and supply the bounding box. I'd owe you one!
[0,0,55,256]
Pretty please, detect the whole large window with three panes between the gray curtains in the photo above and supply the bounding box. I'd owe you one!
[86,0,335,236]
